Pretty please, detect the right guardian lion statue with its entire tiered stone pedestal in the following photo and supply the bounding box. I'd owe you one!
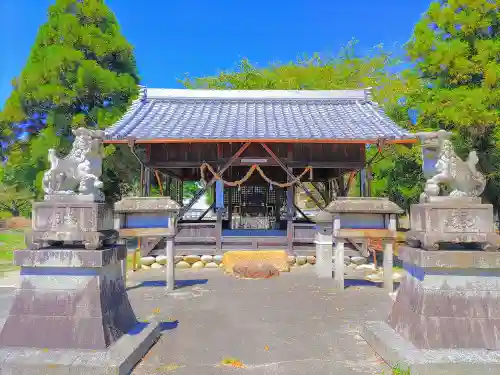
[363,132,500,375]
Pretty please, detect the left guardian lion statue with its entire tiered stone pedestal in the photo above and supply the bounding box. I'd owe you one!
[0,129,160,375]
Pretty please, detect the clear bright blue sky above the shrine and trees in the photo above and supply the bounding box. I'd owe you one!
[0,0,430,108]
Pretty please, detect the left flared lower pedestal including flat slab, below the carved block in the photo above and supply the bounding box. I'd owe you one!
[0,245,160,375]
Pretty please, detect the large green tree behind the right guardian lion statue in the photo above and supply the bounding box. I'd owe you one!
[407,0,500,209]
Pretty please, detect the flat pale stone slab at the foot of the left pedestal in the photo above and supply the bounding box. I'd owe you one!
[0,321,161,375]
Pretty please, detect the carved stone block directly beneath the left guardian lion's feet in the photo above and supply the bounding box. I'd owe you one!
[26,200,118,249]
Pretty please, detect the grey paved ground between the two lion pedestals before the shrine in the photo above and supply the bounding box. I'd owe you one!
[0,269,391,375]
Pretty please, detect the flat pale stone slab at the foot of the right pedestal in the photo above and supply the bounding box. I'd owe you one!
[362,322,500,375]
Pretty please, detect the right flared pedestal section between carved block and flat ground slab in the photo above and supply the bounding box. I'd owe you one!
[387,247,500,350]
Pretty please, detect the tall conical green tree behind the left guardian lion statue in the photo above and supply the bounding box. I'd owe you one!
[0,0,139,201]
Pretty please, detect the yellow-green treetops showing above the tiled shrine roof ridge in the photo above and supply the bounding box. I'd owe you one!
[183,41,416,112]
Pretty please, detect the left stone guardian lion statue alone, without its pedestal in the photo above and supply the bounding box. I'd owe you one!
[42,128,104,201]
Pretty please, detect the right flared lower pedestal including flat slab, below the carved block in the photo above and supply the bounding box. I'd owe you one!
[364,247,500,375]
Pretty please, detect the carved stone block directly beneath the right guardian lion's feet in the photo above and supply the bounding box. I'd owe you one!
[406,201,500,251]
